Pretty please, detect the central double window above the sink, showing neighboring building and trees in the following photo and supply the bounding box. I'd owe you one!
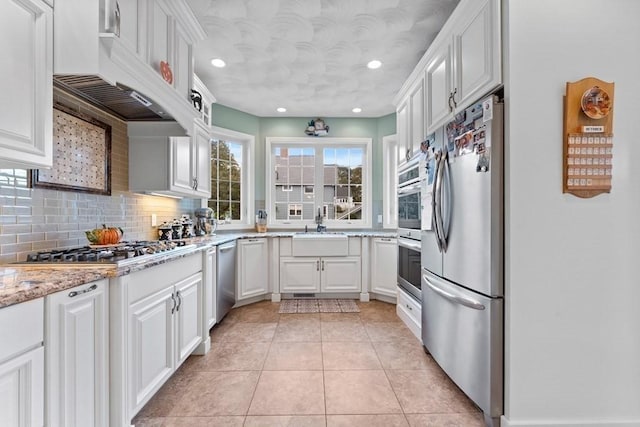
[267,138,371,226]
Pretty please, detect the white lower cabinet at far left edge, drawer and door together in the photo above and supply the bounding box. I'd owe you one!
[0,298,45,427]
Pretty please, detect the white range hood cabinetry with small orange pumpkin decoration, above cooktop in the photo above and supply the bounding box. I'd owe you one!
[54,0,205,132]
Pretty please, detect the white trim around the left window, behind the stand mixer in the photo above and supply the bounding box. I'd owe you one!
[201,126,256,230]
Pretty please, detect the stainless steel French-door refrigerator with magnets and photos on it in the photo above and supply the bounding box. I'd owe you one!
[421,96,504,426]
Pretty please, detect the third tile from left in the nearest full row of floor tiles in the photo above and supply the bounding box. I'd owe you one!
[324,371,402,414]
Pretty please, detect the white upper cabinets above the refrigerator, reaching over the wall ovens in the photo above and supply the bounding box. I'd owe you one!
[396,0,502,135]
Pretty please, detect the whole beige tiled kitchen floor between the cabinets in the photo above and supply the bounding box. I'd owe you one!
[134,301,483,427]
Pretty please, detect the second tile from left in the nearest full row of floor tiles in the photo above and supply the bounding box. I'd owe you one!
[248,371,325,415]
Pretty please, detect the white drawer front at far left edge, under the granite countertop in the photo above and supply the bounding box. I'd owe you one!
[0,298,44,362]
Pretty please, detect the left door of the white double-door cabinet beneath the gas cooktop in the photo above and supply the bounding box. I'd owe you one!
[128,286,177,414]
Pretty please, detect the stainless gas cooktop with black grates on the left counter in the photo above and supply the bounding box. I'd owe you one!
[25,240,195,265]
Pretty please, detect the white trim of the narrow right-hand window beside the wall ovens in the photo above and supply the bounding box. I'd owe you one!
[382,135,398,228]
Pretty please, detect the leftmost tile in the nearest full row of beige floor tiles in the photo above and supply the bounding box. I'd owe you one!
[169,371,260,417]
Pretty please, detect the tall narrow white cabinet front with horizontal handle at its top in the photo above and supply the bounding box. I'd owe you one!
[45,280,109,427]
